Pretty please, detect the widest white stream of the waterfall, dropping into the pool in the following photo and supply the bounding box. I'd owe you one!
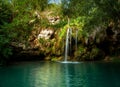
[64,28,71,62]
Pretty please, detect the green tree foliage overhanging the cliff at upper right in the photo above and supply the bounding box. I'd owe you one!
[62,0,120,32]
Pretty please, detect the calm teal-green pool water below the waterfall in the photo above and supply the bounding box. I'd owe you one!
[0,62,120,87]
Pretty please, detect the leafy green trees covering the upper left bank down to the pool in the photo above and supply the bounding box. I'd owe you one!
[0,0,48,61]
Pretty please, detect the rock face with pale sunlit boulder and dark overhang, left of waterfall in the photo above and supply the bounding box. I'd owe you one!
[11,29,54,60]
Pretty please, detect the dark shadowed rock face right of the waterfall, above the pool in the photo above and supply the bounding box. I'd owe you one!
[80,23,120,60]
